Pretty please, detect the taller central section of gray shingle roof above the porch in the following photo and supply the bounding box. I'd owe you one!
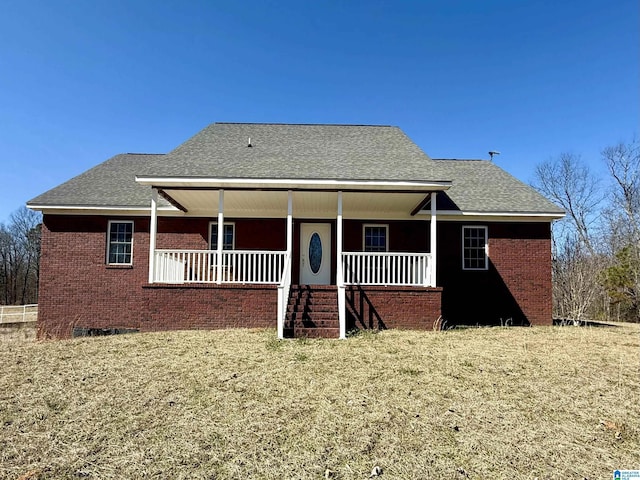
[156,123,442,181]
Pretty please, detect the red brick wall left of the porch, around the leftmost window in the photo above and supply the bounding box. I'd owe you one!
[38,215,149,338]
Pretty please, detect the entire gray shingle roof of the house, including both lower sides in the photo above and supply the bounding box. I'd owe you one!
[28,123,562,213]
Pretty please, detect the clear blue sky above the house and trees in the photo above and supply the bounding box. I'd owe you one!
[0,0,640,222]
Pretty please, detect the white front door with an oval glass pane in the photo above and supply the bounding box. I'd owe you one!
[300,223,331,285]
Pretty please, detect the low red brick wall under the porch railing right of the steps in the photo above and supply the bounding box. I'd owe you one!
[346,286,442,330]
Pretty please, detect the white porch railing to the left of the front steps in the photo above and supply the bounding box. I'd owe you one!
[154,249,287,284]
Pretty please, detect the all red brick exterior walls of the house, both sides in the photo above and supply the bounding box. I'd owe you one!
[38,215,551,338]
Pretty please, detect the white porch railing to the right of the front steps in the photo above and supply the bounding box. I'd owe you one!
[342,252,431,286]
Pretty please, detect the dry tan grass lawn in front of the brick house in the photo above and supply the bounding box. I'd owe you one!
[0,325,640,480]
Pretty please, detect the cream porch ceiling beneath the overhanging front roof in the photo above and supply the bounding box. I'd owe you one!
[163,188,428,219]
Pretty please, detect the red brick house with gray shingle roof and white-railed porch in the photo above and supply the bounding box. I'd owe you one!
[28,123,563,338]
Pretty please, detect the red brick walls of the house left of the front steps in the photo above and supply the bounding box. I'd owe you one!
[38,215,278,338]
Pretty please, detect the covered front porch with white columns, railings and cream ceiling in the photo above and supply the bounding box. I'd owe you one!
[137,177,449,338]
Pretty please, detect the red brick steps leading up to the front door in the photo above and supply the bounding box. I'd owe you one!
[284,285,340,338]
